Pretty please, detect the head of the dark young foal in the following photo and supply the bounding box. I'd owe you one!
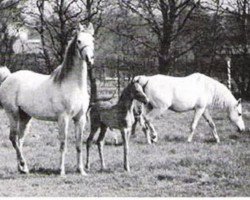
[128,82,149,104]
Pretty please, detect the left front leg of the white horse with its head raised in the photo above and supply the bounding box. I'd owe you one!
[58,114,70,176]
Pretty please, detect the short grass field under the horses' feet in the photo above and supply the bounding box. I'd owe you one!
[0,103,250,197]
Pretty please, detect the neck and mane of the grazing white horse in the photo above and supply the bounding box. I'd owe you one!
[204,76,236,108]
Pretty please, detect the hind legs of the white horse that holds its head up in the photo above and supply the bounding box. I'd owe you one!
[7,112,30,173]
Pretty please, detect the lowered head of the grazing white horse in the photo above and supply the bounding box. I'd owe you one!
[229,99,245,132]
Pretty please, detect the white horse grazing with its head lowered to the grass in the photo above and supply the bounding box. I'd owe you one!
[135,73,245,143]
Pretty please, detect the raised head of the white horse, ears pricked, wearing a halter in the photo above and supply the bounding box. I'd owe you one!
[76,23,94,65]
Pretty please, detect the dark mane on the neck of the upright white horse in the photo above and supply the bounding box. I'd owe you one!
[52,35,77,83]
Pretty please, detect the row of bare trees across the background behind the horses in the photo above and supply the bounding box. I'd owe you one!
[0,0,250,98]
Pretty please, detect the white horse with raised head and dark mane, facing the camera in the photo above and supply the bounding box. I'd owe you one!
[0,24,94,176]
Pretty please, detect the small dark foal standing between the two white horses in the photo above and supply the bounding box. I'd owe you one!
[85,82,154,171]
